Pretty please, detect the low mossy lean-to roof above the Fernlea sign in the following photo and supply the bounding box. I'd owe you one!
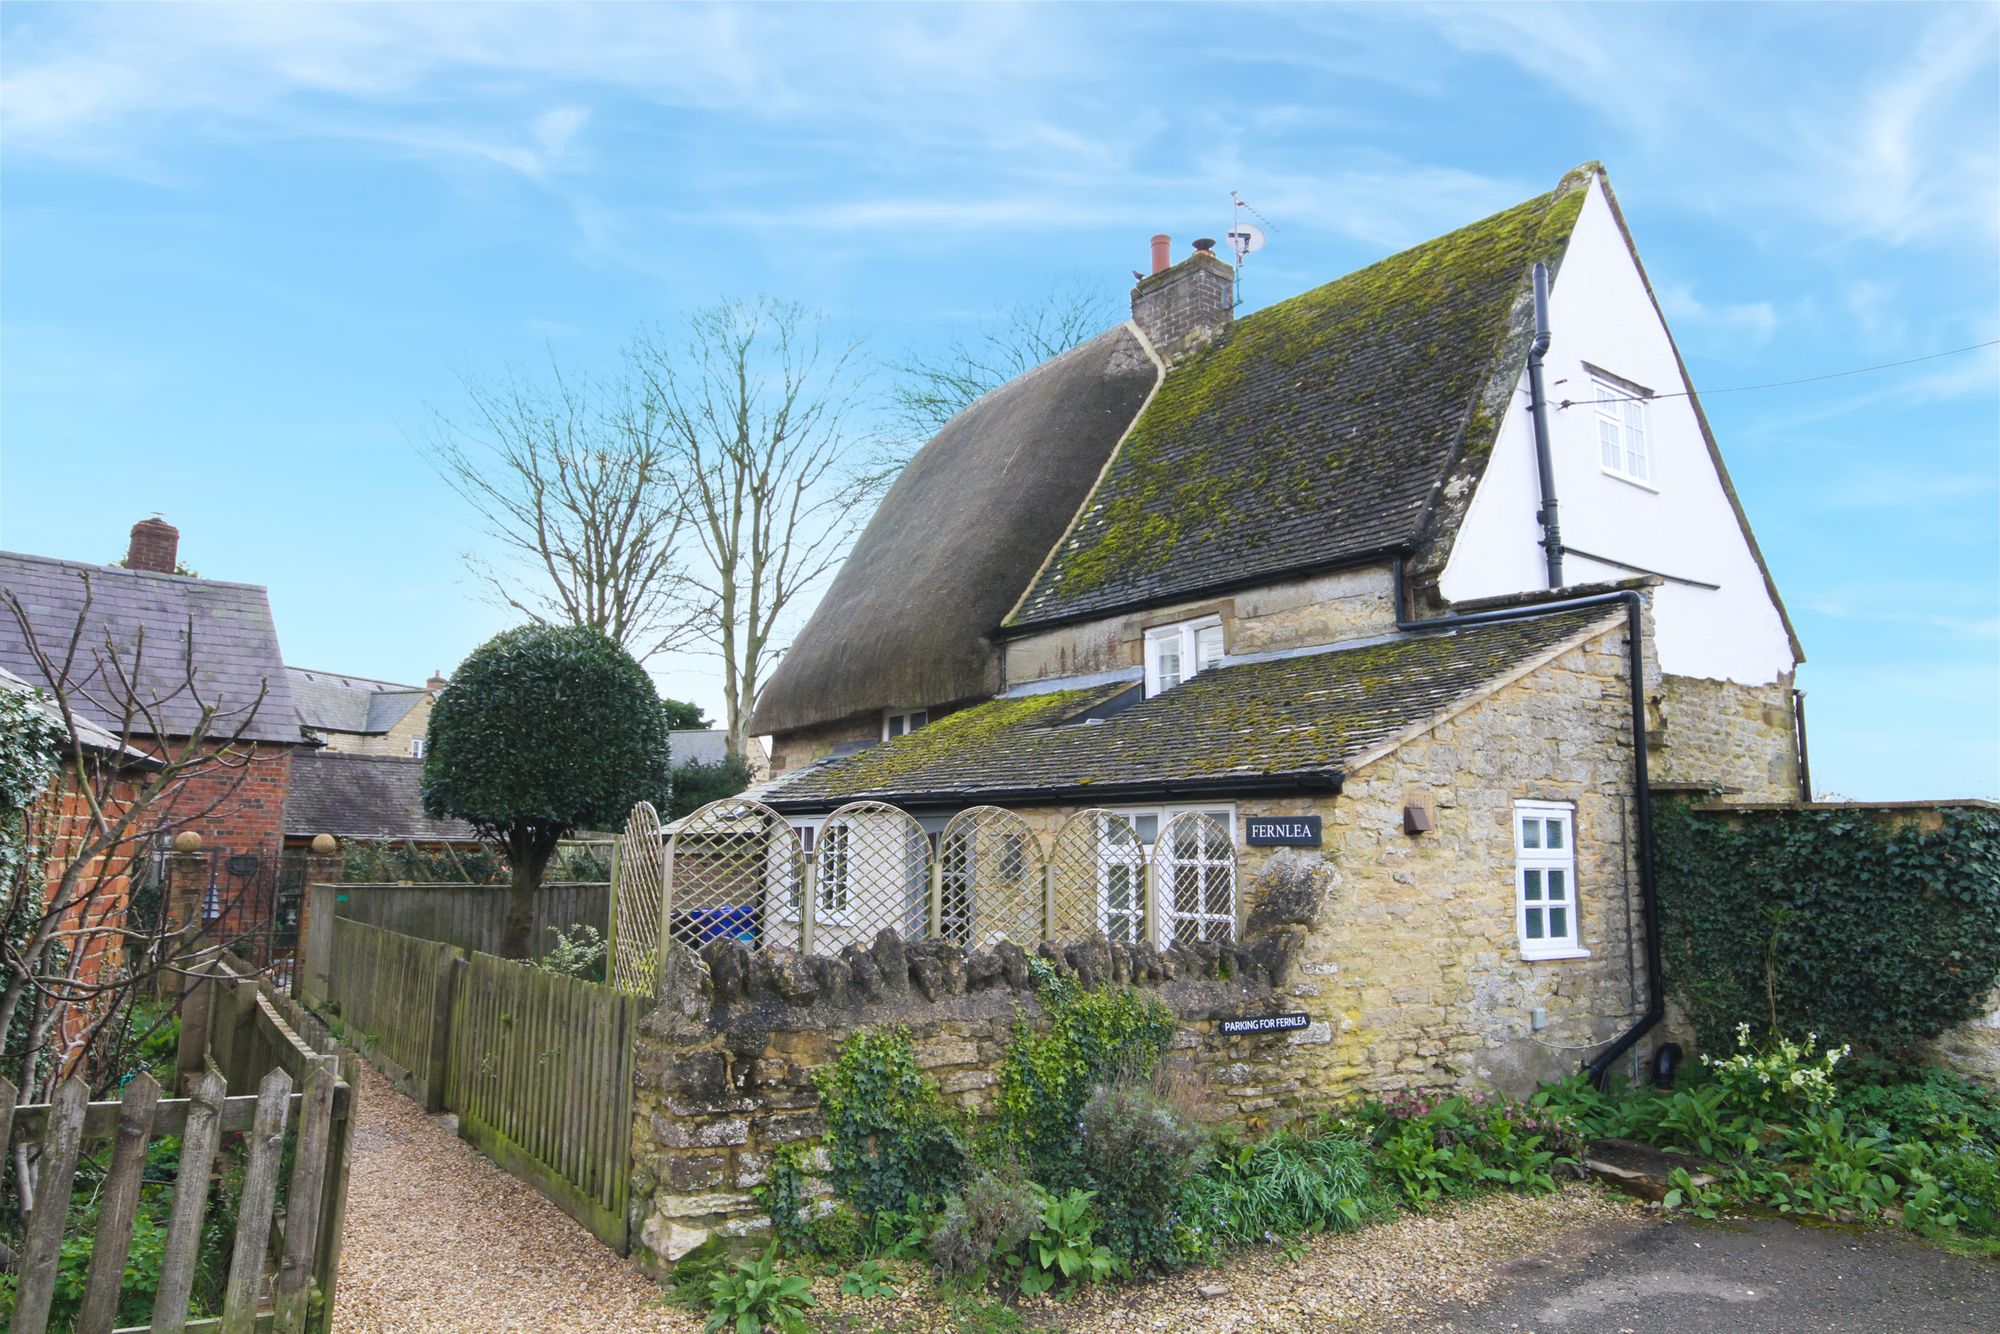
[756,606,1622,810]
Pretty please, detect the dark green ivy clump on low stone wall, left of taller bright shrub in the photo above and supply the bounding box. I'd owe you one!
[812,1028,968,1220]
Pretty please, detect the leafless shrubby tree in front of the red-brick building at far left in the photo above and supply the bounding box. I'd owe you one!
[0,574,278,1100]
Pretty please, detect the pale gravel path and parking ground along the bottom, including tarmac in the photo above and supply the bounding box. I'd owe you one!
[334,1070,2000,1334]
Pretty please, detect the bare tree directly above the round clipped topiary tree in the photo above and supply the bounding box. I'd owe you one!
[424,364,694,662]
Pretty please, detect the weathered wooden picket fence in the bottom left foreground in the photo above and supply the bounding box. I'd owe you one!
[0,964,354,1334]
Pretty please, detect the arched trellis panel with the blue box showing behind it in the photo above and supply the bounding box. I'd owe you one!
[660,796,806,950]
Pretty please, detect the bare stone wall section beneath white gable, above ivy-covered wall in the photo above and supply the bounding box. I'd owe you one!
[1650,672,1798,802]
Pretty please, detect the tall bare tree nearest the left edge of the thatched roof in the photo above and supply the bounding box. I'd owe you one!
[630,298,870,756]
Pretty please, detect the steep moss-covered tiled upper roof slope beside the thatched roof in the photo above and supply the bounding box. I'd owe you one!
[1008,168,1594,626]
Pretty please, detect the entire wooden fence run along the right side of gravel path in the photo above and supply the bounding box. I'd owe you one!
[312,918,640,1254]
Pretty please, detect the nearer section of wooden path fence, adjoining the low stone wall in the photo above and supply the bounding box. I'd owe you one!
[446,954,638,1252]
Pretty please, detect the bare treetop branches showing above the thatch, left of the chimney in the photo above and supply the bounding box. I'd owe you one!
[890,280,1118,456]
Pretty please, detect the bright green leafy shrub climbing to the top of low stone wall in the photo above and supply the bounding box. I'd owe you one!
[998,976,1174,1188]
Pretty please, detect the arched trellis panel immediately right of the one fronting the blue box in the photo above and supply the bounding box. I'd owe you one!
[802,802,932,954]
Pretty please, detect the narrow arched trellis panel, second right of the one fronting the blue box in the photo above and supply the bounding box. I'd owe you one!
[936,806,1048,948]
